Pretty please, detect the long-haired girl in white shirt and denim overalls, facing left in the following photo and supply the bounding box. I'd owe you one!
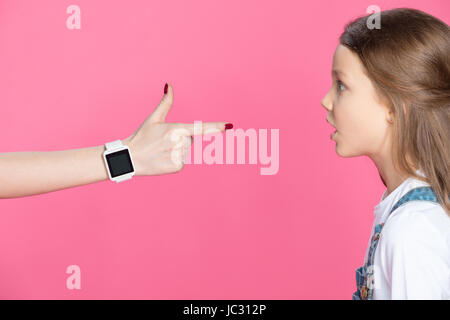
[322,8,450,299]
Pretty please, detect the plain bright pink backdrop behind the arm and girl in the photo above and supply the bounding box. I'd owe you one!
[0,0,450,299]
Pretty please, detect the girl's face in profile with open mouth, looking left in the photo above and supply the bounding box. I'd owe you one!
[321,44,391,157]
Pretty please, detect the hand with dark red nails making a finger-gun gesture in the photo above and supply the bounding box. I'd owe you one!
[123,84,232,176]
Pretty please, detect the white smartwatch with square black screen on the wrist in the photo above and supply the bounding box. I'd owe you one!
[103,140,135,183]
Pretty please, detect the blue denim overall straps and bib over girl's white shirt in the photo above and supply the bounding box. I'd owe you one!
[352,187,438,300]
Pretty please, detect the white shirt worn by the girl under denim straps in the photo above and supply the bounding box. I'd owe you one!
[364,170,450,299]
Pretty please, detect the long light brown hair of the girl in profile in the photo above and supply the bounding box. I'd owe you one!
[339,8,450,216]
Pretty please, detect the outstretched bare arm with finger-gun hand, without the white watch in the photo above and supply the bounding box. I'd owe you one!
[0,84,232,198]
